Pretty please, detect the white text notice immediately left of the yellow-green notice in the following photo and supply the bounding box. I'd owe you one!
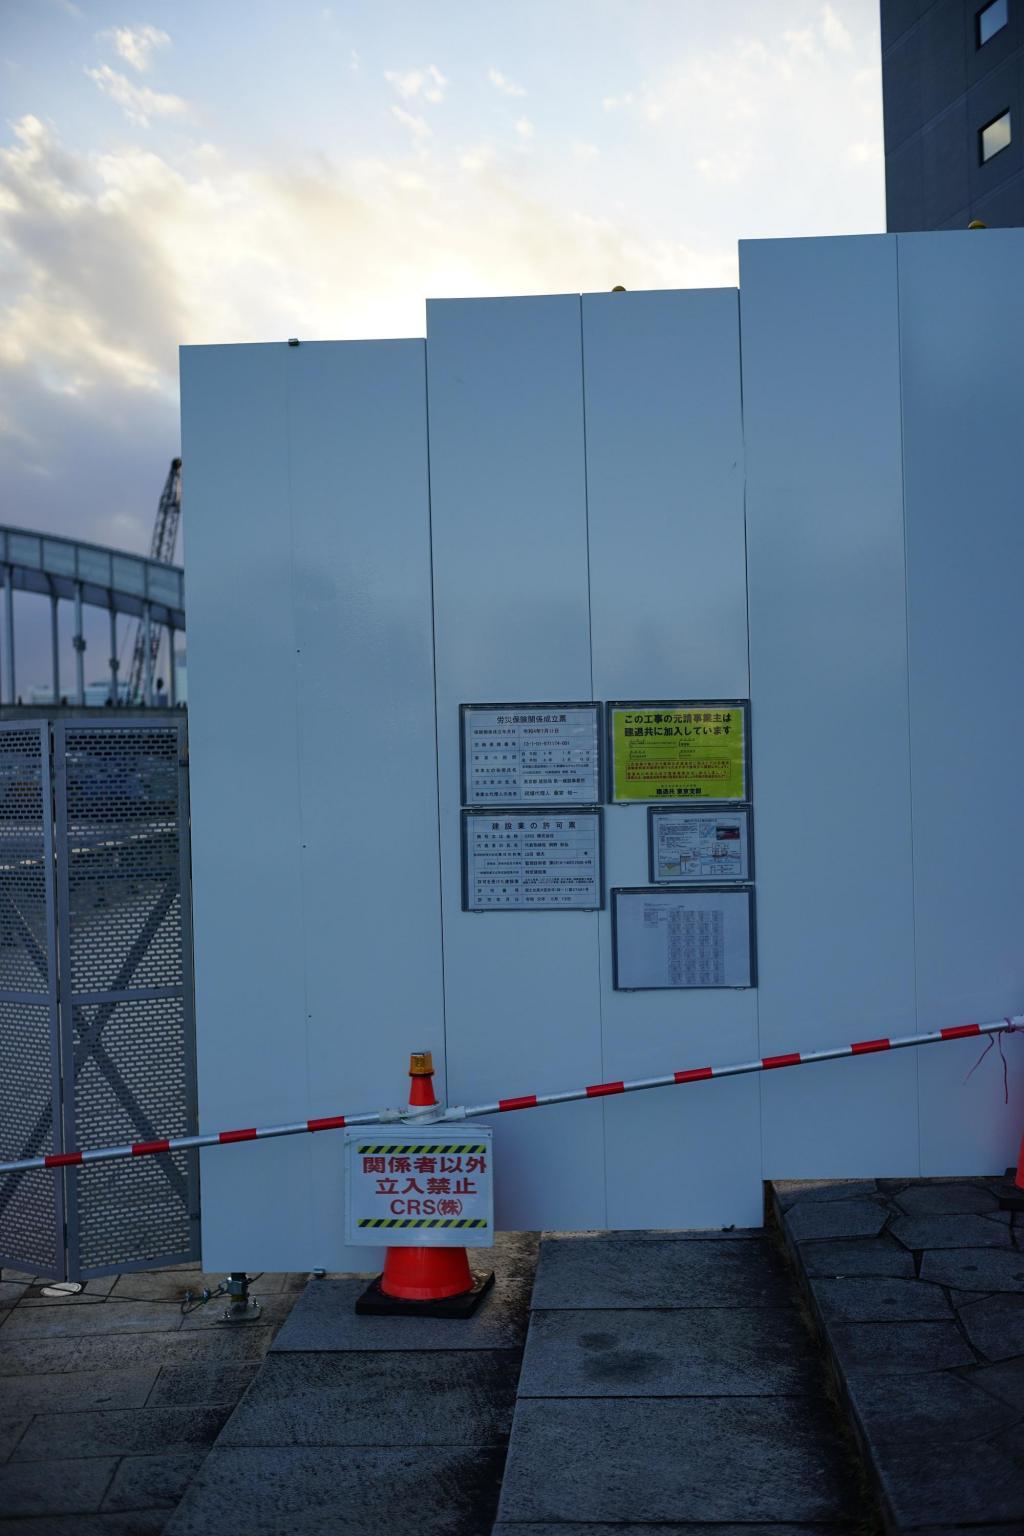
[459,703,602,805]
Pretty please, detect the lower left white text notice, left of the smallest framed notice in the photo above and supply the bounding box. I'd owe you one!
[462,806,603,912]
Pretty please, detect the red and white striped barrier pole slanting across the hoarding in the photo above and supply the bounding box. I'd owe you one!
[0,1014,1024,1174]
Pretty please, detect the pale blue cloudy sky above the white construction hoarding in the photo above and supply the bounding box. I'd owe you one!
[0,0,884,690]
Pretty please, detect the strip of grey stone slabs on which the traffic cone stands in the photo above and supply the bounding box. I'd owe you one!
[164,1232,537,1536]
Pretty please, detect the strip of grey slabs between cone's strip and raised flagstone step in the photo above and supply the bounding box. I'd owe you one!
[494,1230,874,1536]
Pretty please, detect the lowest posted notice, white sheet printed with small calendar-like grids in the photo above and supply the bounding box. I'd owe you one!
[611,886,755,992]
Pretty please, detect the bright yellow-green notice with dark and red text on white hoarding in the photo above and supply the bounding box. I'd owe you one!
[608,700,748,800]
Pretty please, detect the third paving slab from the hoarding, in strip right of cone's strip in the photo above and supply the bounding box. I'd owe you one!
[499,1398,846,1522]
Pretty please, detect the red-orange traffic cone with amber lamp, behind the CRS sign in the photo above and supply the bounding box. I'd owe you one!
[356,1051,494,1318]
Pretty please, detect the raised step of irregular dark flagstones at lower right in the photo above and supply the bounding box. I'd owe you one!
[774,1178,1024,1536]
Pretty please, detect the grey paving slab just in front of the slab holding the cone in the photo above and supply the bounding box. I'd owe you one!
[216,1350,516,1447]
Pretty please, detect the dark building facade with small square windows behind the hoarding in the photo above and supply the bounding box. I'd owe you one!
[881,0,1024,230]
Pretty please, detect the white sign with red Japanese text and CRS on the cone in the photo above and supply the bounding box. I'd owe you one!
[344,1124,494,1247]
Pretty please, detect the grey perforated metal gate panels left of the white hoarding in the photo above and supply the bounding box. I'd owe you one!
[0,719,200,1279]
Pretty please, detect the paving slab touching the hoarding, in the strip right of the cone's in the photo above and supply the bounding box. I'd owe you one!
[533,1236,789,1310]
